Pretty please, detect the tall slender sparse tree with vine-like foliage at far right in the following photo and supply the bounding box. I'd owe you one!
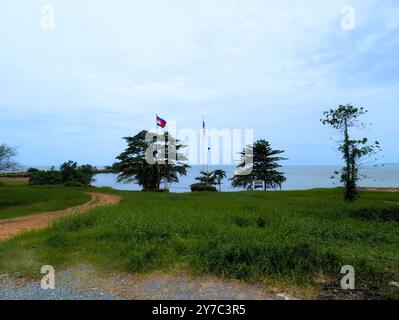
[320,104,380,202]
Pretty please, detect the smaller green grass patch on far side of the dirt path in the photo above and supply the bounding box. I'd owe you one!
[0,182,90,220]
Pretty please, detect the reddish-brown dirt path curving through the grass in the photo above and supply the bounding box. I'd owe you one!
[0,192,121,241]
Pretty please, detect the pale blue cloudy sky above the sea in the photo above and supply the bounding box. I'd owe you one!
[0,0,399,165]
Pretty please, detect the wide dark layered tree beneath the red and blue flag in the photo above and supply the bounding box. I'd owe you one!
[116,130,189,190]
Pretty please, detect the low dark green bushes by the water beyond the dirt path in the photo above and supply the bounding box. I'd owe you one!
[28,161,96,187]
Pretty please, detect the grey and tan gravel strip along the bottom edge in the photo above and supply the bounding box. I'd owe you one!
[0,265,293,300]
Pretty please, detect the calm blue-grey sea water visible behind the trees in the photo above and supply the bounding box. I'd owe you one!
[93,166,399,192]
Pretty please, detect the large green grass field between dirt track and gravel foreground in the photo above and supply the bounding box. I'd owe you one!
[0,189,399,296]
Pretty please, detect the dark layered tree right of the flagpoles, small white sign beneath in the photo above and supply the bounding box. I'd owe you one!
[231,139,287,190]
